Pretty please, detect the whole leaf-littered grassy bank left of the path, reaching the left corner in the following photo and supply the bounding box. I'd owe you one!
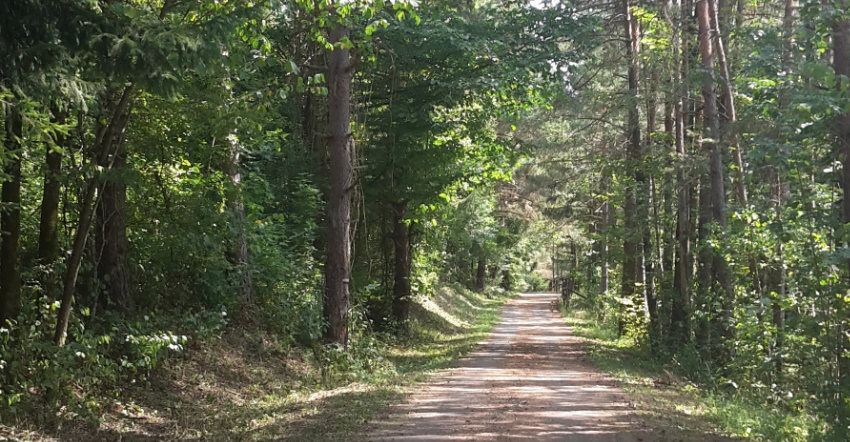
[0,286,512,440]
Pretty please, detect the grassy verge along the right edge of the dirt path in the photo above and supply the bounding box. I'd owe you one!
[566,311,819,441]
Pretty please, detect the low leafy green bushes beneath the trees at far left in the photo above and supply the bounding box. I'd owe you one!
[0,297,205,419]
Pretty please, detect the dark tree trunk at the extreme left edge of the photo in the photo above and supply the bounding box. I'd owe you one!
[0,106,23,326]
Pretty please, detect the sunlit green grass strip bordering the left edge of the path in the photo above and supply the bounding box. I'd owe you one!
[200,288,511,440]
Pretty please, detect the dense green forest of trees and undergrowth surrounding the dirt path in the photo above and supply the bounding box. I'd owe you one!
[0,0,850,441]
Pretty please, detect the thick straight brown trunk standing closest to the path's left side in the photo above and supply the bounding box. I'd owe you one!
[323,25,354,345]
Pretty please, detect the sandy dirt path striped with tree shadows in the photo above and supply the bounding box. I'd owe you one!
[356,294,648,442]
